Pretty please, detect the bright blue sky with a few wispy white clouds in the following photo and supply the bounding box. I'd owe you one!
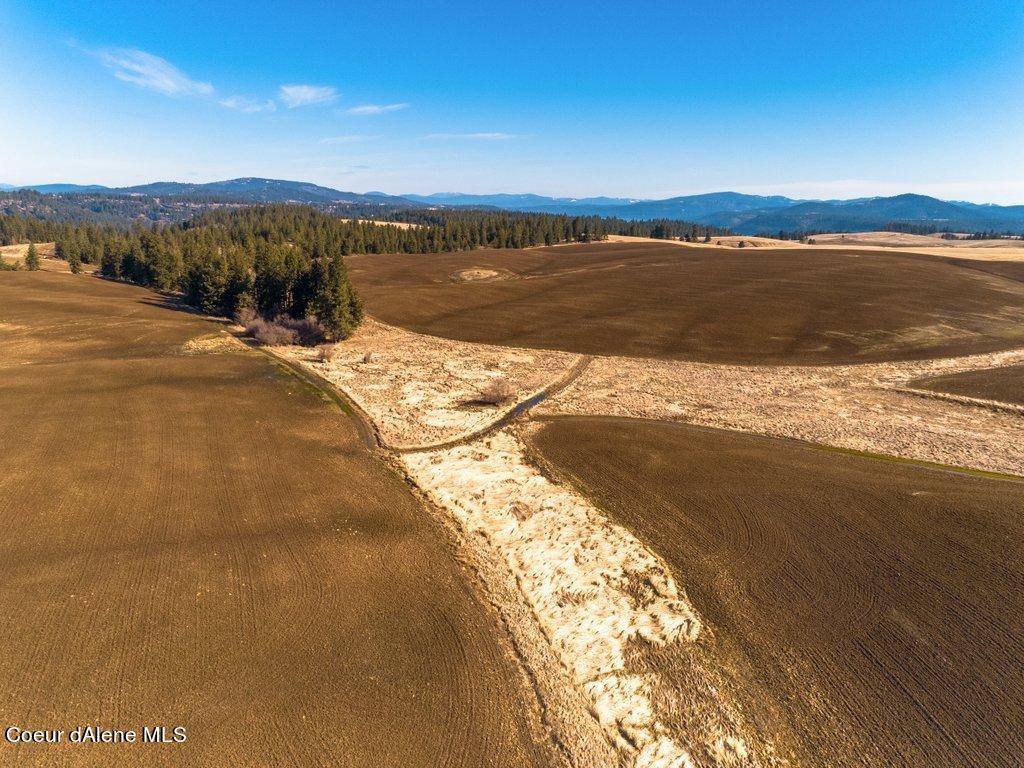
[0,0,1024,203]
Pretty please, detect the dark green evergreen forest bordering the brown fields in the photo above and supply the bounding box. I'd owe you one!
[6,204,723,338]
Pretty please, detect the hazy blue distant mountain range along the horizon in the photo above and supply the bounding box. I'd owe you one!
[0,178,1024,234]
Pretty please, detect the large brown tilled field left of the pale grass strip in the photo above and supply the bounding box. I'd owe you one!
[0,272,553,768]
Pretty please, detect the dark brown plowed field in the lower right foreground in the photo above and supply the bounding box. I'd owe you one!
[532,418,1024,767]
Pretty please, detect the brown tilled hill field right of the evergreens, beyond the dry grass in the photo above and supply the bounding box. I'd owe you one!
[349,243,1024,365]
